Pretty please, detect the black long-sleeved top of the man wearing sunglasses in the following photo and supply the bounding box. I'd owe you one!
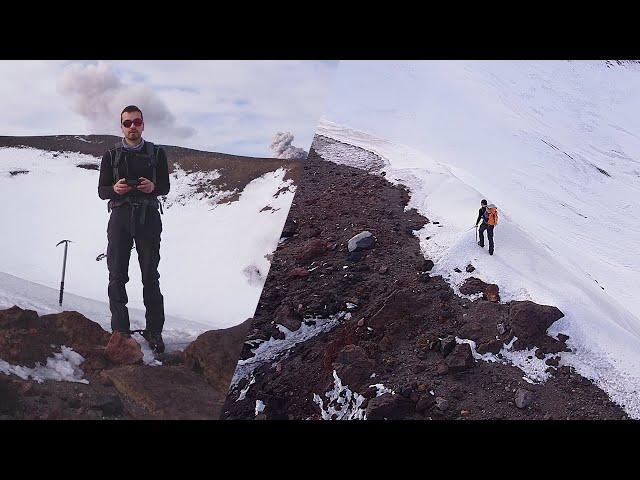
[98,142,169,200]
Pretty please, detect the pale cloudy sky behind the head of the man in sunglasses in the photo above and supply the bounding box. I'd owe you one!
[0,60,337,156]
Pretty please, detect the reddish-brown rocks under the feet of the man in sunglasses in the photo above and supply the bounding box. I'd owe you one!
[0,307,248,420]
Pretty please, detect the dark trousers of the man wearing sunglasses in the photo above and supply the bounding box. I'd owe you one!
[107,204,164,333]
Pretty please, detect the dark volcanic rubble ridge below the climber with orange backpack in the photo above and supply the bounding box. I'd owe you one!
[222,150,626,420]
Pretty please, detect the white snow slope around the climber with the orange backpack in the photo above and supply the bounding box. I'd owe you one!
[317,62,640,417]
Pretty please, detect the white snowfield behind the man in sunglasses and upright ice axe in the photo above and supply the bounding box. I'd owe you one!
[0,142,295,333]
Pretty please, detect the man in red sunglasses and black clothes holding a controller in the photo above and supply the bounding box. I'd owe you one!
[98,105,169,353]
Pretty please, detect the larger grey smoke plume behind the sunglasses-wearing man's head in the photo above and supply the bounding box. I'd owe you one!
[58,62,196,142]
